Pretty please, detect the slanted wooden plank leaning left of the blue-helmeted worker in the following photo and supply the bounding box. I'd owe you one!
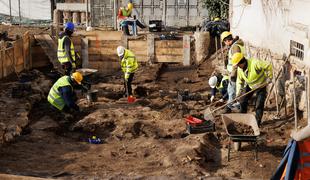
[34,34,63,72]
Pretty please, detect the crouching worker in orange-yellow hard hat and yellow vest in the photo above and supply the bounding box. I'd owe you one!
[47,72,83,112]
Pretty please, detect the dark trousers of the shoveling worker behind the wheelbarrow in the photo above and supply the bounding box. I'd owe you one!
[240,86,267,125]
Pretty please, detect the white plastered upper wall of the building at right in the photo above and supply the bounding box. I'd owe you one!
[230,0,310,66]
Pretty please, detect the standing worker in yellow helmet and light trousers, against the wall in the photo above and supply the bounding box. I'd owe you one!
[221,31,245,113]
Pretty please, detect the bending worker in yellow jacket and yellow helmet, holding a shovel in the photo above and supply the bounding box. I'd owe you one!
[232,52,273,125]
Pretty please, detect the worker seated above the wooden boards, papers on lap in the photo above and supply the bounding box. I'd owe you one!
[117,2,145,36]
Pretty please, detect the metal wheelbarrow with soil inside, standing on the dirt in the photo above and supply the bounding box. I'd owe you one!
[222,113,260,161]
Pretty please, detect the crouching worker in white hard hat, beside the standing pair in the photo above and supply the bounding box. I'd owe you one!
[209,74,229,103]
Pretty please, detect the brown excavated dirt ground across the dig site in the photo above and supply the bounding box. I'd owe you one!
[0,52,302,179]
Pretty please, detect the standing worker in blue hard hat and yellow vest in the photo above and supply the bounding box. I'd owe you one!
[57,22,76,76]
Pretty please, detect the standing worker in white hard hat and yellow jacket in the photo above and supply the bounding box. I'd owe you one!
[116,46,139,96]
